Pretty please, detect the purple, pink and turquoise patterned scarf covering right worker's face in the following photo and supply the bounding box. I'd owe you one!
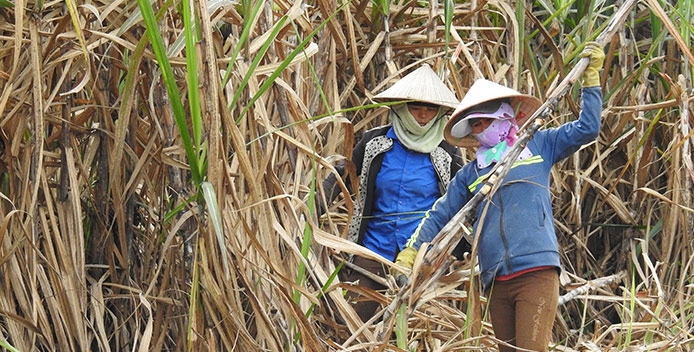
[474,109,532,169]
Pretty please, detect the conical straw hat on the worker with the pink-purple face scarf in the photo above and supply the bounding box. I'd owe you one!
[443,79,542,147]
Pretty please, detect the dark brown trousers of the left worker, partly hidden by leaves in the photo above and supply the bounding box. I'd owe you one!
[342,256,386,322]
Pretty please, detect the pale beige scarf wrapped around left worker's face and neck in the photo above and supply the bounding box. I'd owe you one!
[389,104,446,154]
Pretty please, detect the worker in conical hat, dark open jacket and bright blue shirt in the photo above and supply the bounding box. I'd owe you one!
[323,65,464,321]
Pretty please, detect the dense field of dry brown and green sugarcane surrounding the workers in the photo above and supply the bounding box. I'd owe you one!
[0,0,694,352]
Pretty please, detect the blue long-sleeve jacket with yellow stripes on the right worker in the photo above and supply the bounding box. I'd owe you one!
[407,87,602,287]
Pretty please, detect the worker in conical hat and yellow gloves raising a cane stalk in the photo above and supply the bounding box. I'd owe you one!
[396,43,605,352]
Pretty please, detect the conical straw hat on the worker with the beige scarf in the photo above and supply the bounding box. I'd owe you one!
[374,64,459,109]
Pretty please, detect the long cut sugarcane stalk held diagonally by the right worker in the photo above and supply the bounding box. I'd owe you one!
[384,0,637,326]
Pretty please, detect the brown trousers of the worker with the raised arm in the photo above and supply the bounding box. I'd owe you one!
[489,269,559,352]
